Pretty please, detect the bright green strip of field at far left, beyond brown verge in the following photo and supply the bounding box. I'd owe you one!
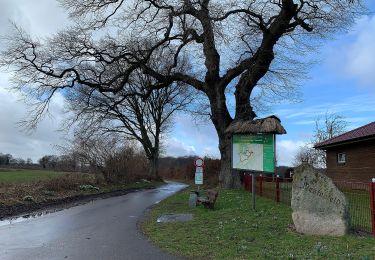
[0,169,64,183]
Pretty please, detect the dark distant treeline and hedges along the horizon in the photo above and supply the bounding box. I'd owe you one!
[0,151,220,185]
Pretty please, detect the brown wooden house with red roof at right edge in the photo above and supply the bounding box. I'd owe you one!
[314,122,375,182]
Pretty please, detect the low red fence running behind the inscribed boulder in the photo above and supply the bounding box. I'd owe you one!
[244,174,375,236]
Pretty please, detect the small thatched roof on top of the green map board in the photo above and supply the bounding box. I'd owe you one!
[225,116,286,134]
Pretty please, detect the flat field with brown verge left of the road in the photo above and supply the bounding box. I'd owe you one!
[0,169,162,209]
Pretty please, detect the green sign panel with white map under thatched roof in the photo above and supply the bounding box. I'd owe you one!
[232,134,275,172]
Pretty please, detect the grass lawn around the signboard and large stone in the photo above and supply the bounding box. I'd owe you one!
[142,190,375,259]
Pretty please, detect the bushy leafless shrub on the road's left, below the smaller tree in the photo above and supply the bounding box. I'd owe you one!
[58,129,152,183]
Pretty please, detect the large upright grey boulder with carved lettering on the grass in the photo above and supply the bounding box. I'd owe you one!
[291,164,350,236]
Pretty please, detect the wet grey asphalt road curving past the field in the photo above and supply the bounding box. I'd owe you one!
[0,183,188,260]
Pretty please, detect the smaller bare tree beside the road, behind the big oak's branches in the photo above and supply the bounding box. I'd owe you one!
[66,69,193,179]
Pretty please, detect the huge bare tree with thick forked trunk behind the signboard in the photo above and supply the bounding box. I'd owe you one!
[0,0,362,188]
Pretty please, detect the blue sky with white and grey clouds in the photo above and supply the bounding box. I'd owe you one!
[0,0,375,165]
